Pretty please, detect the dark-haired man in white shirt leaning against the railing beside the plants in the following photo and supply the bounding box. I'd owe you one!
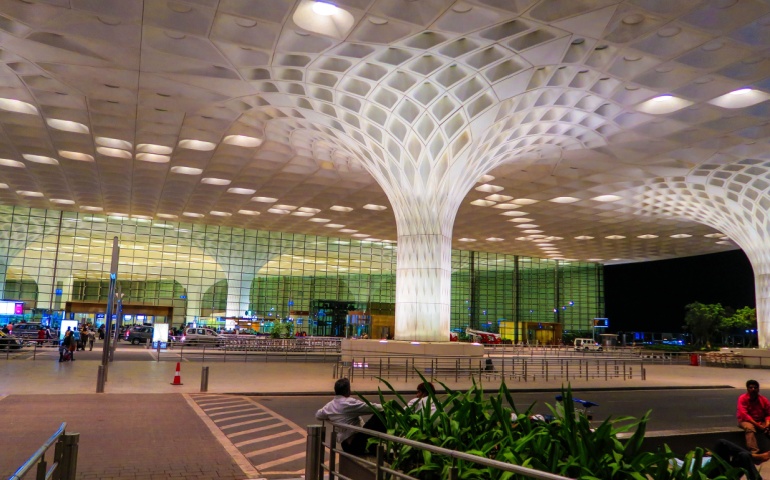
[315,378,386,455]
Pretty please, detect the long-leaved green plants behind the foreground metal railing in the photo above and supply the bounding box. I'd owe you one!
[361,372,740,480]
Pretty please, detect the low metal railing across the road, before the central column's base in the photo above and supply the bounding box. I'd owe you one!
[340,355,646,382]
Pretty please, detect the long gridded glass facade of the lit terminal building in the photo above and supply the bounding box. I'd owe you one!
[0,206,604,335]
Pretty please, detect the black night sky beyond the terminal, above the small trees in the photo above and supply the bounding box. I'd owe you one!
[604,250,756,334]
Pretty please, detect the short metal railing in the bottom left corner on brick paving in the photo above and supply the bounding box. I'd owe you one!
[8,422,80,480]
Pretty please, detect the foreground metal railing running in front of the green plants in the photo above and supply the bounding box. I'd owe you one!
[305,422,570,480]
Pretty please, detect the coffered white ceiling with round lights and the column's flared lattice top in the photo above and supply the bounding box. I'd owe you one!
[0,0,770,263]
